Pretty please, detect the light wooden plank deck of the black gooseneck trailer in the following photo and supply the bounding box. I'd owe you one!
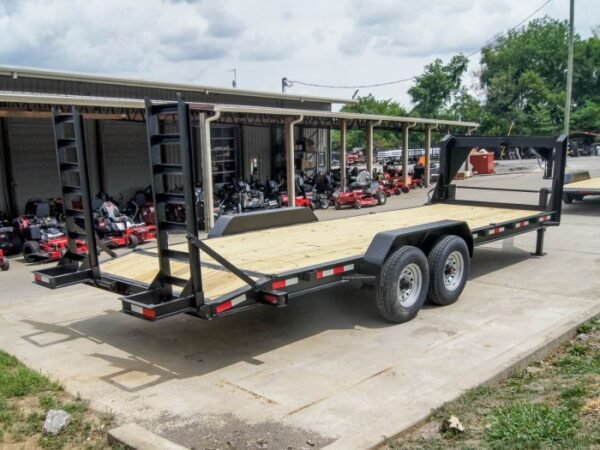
[101,203,539,299]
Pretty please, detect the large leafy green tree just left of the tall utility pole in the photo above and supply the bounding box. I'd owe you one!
[480,18,568,134]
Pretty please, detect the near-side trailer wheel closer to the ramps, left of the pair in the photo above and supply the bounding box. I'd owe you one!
[376,246,429,323]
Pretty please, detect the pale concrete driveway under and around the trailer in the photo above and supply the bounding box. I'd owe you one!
[0,167,600,449]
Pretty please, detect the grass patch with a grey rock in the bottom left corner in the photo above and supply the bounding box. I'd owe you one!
[0,351,114,450]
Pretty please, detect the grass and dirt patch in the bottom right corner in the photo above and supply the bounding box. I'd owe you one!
[383,318,600,450]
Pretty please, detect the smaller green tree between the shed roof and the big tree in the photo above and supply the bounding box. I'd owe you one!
[408,54,469,117]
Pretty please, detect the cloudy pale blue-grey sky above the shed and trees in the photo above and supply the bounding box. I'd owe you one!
[0,0,600,106]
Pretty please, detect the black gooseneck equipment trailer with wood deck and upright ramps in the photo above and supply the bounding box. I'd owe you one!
[34,100,566,323]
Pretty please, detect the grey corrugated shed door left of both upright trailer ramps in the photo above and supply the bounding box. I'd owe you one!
[8,119,60,213]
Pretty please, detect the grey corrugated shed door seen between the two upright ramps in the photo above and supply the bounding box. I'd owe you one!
[102,121,150,200]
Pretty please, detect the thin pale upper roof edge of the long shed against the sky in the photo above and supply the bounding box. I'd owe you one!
[0,66,354,104]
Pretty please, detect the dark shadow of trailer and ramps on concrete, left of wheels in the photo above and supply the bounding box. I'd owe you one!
[18,286,390,392]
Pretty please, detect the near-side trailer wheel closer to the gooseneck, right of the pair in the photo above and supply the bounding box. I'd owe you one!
[427,235,471,306]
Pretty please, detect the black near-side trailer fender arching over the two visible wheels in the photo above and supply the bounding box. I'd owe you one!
[360,220,473,275]
